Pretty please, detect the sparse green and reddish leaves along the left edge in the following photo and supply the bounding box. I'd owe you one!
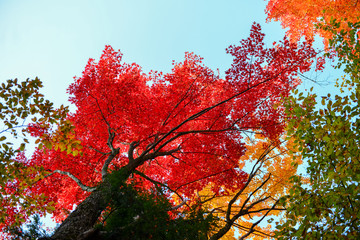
[0,78,68,228]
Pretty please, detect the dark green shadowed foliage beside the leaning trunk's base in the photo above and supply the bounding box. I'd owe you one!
[98,173,216,240]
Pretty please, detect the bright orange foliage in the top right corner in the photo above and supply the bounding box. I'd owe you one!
[266,0,360,46]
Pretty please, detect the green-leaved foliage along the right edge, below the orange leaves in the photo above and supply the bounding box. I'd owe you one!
[277,22,360,239]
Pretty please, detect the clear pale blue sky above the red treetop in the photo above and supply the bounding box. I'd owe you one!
[0,0,292,105]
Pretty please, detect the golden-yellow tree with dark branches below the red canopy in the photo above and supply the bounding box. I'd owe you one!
[193,134,302,240]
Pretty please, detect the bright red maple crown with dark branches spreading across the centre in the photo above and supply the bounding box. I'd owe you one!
[4,24,322,239]
